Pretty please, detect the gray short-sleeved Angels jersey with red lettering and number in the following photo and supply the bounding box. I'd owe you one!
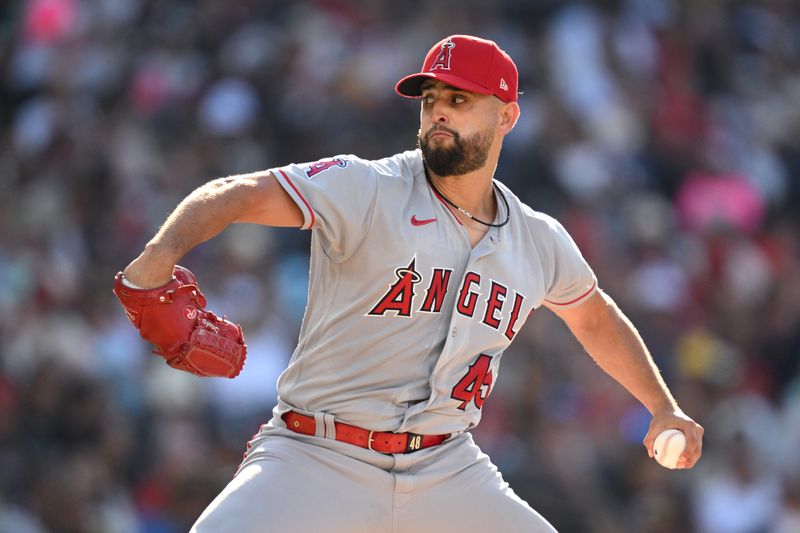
[272,150,597,434]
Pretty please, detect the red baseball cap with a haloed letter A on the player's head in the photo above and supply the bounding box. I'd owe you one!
[394,35,519,102]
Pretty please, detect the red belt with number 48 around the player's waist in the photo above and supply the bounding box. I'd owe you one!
[281,411,450,454]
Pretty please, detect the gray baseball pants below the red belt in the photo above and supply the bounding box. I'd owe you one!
[191,421,555,533]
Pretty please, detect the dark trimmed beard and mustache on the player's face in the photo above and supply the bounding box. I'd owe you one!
[417,126,494,177]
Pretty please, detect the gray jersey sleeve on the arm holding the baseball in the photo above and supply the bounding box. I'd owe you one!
[545,218,597,308]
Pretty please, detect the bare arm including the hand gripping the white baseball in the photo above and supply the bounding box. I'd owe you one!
[550,290,703,468]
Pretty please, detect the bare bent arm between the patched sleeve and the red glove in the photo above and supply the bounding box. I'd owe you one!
[124,172,303,288]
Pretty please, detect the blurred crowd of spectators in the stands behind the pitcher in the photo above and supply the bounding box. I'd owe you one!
[0,0,800,533]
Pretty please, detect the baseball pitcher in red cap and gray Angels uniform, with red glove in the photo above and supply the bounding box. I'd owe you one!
[114,35,703,533]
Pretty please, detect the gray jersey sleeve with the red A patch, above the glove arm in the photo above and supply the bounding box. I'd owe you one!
[270,155,378,261]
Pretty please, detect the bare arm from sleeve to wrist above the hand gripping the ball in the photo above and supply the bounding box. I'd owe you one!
[572,293,678,414]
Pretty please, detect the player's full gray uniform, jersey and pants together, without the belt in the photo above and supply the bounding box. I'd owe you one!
[192,151,596,533]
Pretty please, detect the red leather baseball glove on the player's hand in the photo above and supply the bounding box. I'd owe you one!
[114,265,247,378]
